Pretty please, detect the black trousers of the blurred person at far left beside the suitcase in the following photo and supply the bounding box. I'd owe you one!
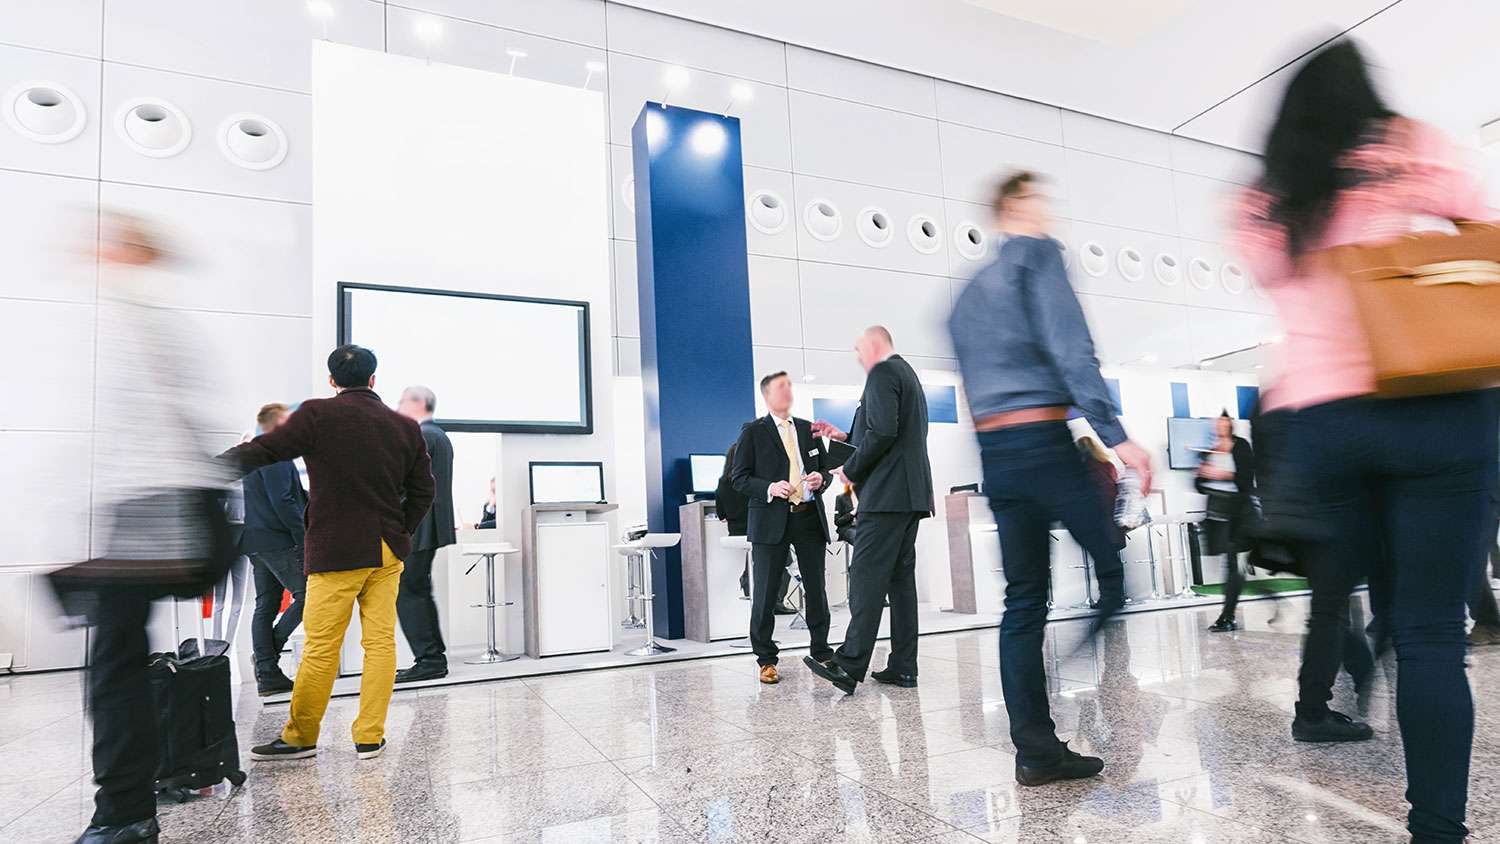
[89,586,158,826]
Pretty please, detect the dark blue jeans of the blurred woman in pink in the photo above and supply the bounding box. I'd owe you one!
[1283,393,1497,843]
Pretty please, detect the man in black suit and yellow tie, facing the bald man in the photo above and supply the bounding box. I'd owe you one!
[734,372,833,685]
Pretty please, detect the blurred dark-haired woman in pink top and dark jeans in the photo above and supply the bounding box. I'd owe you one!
[1236,40,1497,843]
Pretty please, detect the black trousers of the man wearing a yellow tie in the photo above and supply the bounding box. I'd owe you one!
[750,504,833,666]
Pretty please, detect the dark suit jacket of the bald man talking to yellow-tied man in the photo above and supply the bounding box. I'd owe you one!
[843,355,933,516]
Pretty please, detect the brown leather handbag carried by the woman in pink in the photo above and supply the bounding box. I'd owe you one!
[1319,222,1500,397]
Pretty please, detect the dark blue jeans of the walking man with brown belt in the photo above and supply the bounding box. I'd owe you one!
[980,421,1125,766]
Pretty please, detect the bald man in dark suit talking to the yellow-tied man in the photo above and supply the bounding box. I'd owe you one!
[806,325,933,694]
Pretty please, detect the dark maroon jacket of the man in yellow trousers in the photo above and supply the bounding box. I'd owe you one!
[221,387,435,574]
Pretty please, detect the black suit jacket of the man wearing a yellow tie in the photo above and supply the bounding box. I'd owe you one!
[734,414,830,543]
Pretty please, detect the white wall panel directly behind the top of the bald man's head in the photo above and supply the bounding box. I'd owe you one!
[801,261,953,357]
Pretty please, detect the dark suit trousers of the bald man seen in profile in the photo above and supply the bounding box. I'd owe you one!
[834,511,926,681]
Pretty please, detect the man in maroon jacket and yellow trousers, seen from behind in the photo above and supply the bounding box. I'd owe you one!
[224,345,435,760]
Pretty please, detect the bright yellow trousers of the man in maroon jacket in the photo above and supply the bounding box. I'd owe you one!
[282,541,405,747]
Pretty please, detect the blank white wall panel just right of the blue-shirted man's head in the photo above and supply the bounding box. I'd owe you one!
[1067,150,1178,234]
